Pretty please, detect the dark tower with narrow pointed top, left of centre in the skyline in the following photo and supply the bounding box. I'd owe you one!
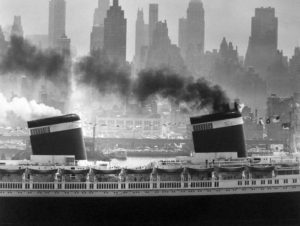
[103,0,127,63]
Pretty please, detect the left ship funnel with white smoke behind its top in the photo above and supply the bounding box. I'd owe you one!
[27,114,86,160]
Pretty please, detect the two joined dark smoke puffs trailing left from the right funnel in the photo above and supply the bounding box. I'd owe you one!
[76,51,229,112]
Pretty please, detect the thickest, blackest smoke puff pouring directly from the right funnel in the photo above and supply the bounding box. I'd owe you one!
[133,69,229,112]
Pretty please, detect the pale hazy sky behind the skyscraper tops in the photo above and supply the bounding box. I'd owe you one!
[0,0,300,60]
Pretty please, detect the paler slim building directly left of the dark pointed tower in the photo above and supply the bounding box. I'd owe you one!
[90,0,109,52]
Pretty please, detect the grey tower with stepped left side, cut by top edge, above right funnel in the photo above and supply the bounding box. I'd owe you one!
[179,0,205,76]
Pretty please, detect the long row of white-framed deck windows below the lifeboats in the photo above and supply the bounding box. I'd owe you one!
[0,177,300,191]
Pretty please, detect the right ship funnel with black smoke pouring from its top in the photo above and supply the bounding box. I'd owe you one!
[190,109,246,160]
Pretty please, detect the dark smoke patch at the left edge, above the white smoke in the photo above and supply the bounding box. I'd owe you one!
[0,36,66,80]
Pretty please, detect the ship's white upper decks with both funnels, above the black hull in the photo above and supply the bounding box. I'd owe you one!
[0,111,300,197]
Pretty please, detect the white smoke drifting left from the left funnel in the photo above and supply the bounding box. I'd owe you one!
[0,93,61,125]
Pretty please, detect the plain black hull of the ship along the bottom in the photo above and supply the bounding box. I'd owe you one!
[0,192,300,225]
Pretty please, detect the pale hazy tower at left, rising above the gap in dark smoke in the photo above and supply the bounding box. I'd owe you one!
[48,0,66,48]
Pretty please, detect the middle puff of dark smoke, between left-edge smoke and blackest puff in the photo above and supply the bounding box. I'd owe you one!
[75,51,131,96]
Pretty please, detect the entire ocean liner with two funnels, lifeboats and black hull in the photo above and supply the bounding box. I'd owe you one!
[0,110,300,224]
